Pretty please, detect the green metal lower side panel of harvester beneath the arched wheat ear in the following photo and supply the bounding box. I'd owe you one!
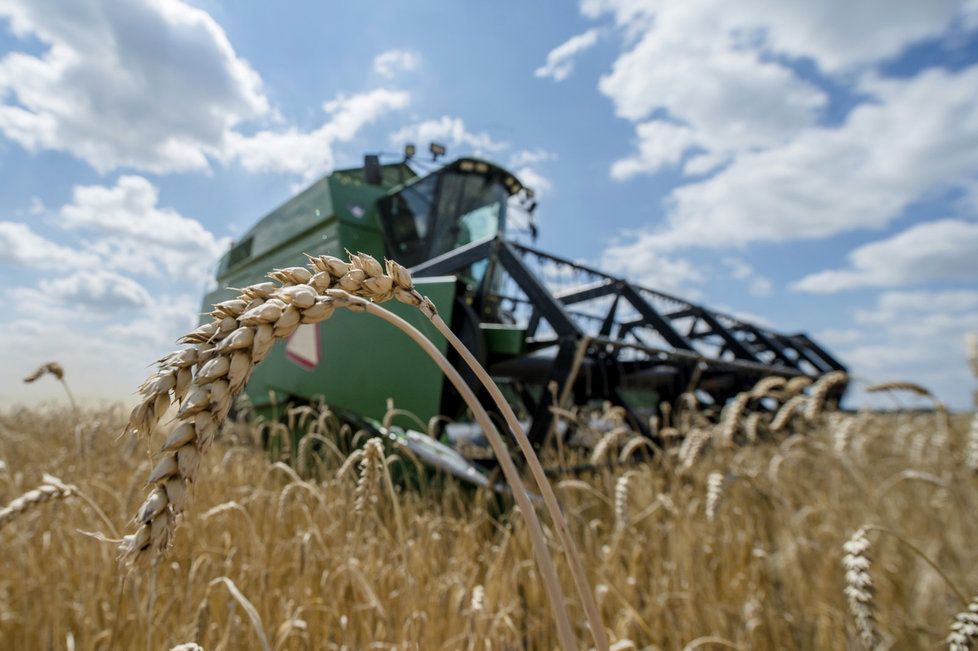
[246,277,455,420]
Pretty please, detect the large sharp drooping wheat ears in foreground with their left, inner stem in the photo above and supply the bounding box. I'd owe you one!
[120,254,574,649]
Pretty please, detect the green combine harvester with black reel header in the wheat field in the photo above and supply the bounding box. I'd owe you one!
[203,144,845,474]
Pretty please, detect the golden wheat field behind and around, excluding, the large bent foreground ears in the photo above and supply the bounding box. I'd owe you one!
[0,394,978,649]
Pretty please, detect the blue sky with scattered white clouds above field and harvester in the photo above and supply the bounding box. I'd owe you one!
[0,0,978,407]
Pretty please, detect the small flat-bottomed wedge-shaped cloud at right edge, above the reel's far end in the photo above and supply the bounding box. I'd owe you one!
[793,219,978,293]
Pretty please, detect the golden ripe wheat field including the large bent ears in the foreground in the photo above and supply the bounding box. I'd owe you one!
[7,262,978,651]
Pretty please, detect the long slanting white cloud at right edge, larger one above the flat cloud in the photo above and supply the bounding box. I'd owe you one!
[616,66,978,249]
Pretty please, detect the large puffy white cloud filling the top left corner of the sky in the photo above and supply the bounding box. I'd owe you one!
[0,0,269,172]
